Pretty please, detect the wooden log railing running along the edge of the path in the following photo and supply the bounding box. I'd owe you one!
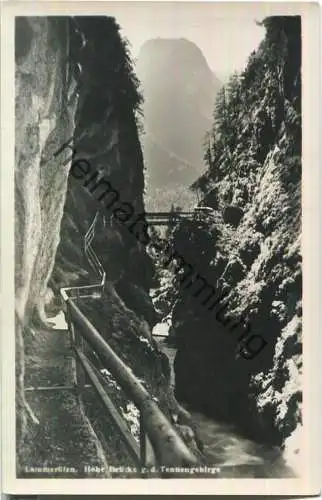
[61,213,197,475]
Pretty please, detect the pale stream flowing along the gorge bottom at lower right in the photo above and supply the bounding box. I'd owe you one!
[155,337,294,478]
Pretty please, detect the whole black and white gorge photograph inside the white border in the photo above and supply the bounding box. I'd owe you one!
[2,1,315,493]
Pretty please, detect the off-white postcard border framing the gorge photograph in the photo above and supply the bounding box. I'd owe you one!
[1,0,322,495]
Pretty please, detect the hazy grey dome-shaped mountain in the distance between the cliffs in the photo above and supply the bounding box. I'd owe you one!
[136,38,220,205]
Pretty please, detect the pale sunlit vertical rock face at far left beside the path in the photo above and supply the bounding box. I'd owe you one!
[15,17,76,454]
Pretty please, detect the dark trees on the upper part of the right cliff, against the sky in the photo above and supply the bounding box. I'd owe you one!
[205,17,301,194]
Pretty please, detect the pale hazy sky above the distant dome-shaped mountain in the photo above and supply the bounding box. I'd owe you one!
[107,2,265,77]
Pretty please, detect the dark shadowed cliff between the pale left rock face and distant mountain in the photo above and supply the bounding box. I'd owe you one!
[51,17,154,322]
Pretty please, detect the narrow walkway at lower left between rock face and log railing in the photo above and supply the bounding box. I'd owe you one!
[19,329,107,478]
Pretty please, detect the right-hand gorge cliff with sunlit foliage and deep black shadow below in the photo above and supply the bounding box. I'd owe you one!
[173,17,302,458]
